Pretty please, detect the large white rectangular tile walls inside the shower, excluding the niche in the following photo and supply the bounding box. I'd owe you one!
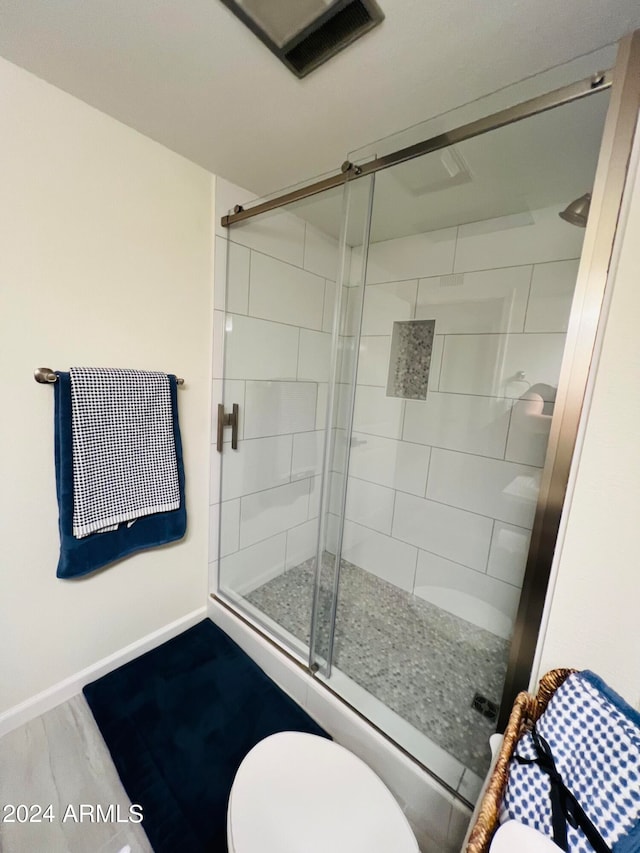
[211,198,583,637]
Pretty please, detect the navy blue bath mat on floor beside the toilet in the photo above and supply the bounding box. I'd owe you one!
[83,619,328,853]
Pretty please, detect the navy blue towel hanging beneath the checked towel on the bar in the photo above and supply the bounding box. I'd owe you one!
[54,373,187,578]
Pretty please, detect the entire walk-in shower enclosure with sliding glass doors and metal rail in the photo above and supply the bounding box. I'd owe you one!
[212,33,640,802]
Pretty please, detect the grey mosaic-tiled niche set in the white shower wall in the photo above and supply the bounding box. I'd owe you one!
[387,320,436,400]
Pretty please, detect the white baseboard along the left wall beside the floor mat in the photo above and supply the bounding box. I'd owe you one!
[0,606,207,737]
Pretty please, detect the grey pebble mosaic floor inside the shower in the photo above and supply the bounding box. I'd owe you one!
[247,560,509,776]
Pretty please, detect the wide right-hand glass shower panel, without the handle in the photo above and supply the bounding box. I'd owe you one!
[322,86,608,799]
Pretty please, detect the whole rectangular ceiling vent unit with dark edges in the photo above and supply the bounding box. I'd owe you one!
[222,0,384,77]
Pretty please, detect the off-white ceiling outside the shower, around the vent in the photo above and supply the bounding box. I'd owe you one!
[0,0,640,200]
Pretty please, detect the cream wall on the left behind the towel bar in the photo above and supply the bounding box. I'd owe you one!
[0,60,213,712]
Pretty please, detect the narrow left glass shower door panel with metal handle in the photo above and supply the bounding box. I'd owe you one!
[219,178,376,661]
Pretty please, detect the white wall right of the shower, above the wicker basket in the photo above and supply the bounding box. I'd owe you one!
[537,118,640,707]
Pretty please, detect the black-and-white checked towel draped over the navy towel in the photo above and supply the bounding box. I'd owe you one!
[69,367,180,539]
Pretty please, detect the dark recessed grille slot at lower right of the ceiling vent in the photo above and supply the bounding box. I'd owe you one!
[284,0,378,77]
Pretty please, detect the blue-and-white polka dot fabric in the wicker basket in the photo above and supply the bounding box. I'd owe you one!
[501,670,640,853]
